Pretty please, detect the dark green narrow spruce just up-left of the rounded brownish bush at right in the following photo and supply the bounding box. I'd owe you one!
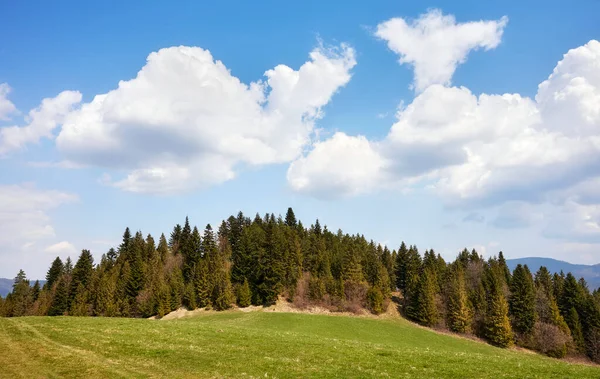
[509,264,537,335]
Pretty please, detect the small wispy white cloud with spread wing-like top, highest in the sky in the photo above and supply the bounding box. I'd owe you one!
[375,9,508,91]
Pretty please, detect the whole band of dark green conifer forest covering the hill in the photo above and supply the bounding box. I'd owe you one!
[0,208,600,362]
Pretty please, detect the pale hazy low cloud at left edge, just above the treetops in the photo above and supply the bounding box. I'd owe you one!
[0,184,78,276]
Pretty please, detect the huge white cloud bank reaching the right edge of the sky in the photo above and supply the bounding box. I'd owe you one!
[288,40,600,239]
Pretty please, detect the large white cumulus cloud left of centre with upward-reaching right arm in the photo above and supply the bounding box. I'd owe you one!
[57,45,356,193]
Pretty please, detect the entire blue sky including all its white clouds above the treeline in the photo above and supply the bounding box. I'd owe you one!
[0,1,600,278]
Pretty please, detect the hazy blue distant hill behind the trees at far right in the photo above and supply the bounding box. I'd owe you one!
[506,257,600,290]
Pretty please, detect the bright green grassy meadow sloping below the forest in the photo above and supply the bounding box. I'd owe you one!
[0,311,600,378]
